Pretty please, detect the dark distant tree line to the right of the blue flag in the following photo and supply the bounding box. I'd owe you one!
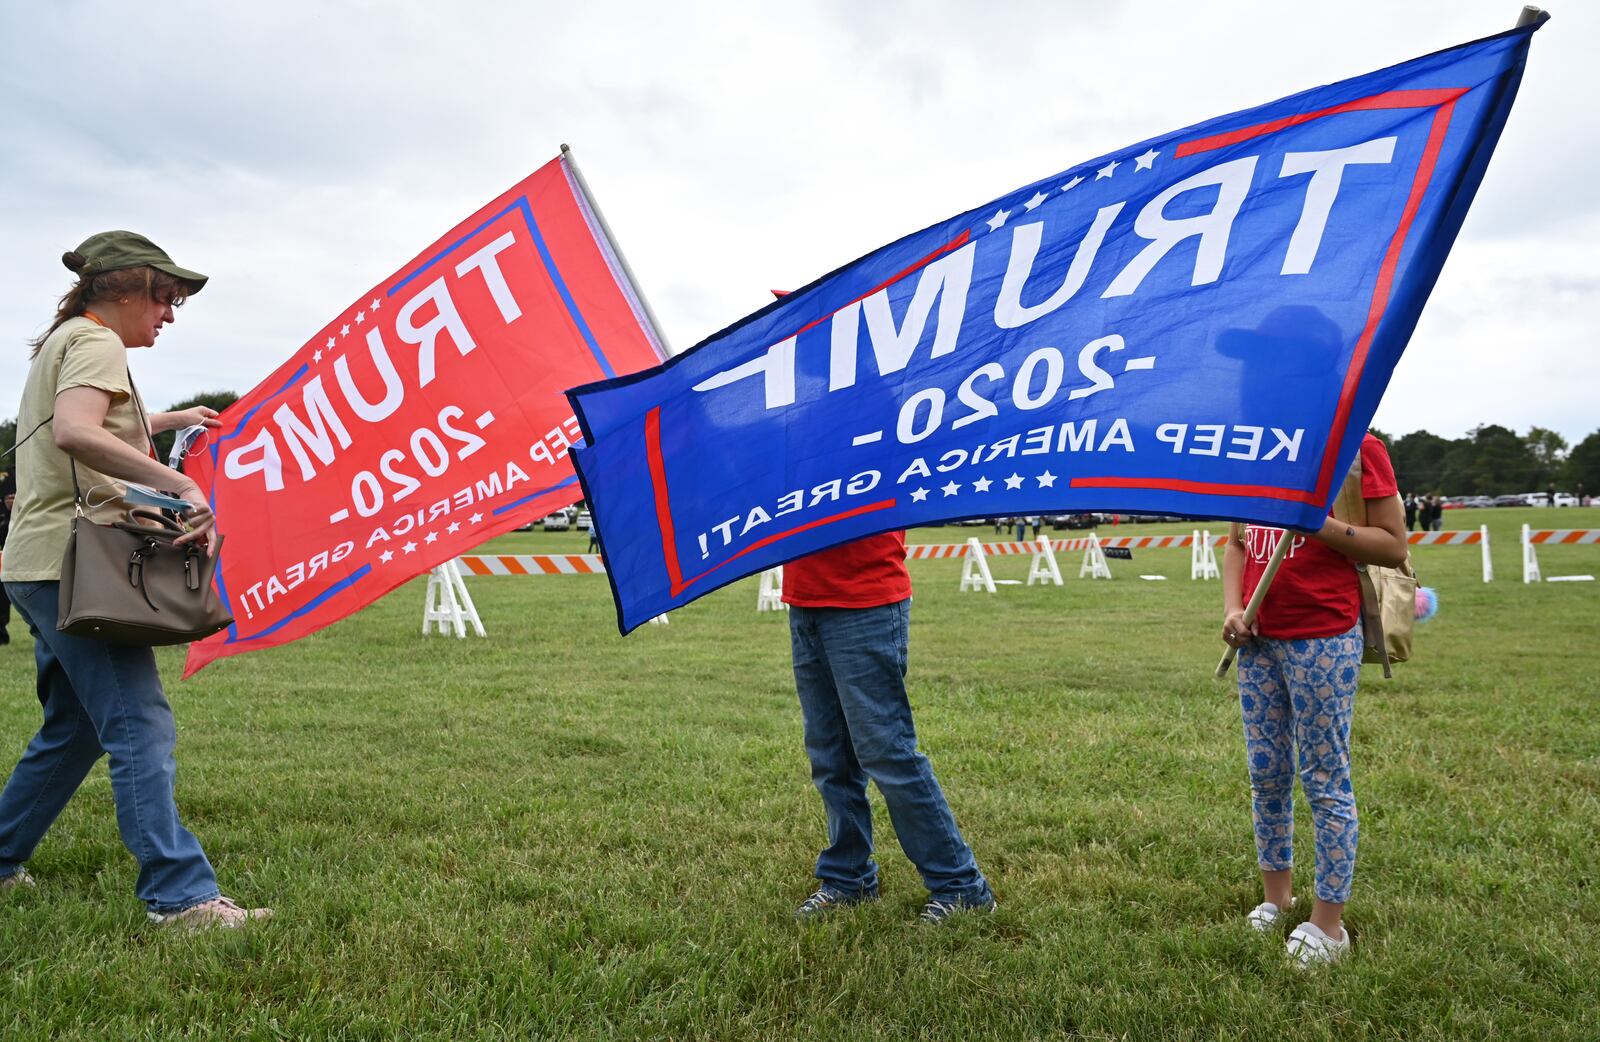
[1373,424,1600,496]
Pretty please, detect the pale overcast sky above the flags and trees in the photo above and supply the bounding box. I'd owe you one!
[0,0,1600,442]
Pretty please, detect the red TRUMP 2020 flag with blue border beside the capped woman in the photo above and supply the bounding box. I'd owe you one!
[184,157,664,675]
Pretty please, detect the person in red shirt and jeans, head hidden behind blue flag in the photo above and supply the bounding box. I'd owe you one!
[784,531,995,922]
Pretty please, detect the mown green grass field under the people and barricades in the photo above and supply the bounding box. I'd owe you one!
[0,509,1600,1042]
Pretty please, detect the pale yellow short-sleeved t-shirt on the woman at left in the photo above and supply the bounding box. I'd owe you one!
[0,319,150,583]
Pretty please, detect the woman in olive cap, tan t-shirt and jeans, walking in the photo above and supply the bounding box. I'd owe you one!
[0,232,270,928]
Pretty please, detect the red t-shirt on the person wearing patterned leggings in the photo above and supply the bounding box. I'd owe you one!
[1243,434,1398,640]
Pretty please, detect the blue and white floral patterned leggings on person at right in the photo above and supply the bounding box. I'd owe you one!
[1238,626,1362,904]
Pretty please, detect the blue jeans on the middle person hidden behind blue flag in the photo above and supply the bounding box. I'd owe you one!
[789,600,989,901]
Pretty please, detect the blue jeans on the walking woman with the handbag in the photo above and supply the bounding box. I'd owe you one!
[0,583,218,912]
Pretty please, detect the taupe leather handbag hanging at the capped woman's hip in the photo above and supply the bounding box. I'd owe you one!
[56,509,234,645]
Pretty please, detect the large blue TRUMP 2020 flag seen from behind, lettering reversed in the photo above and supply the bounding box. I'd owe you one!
[568,18,1536,632]
